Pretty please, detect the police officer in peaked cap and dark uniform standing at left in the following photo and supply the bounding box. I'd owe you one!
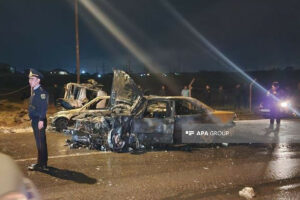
[28,69,49,171]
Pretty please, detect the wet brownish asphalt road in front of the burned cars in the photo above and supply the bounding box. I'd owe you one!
[0,120,300,200]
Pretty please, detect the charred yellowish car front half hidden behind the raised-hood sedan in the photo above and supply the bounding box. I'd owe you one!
[50,96,110,131]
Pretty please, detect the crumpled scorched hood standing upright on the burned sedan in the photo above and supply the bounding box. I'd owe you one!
[110,70,143,112]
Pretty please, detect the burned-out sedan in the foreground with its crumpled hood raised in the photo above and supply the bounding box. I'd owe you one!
[66,70,235,152]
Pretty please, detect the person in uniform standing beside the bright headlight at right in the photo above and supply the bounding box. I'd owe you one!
[267,81,283,126]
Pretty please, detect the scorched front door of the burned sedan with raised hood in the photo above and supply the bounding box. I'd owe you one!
[132,100,175,144]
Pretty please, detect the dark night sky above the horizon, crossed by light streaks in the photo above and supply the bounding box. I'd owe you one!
[0,0,300,73]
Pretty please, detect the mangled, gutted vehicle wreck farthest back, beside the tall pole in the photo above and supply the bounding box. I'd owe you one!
[57,79,107,110]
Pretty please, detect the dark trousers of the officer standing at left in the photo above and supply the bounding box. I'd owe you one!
[31,119,48,166]
